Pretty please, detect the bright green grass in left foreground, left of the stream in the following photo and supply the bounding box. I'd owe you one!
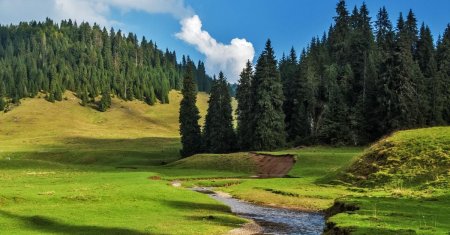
[0,160,245,234]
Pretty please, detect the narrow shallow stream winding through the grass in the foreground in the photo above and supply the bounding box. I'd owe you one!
[194,189,325,235]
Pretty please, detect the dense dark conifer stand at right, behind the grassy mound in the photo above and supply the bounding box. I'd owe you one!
[253,1,450,146]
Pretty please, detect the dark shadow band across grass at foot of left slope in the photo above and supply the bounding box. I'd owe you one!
[0,137,180,169]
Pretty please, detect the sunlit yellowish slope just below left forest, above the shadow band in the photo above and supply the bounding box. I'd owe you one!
[0,90,208,150]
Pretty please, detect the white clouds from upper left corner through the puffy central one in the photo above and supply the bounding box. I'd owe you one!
[0,0,255,82]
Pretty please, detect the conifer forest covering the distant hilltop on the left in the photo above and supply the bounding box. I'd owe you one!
[0,19,212,111]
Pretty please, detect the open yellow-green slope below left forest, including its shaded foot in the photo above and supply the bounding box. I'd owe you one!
[0,90,208,165]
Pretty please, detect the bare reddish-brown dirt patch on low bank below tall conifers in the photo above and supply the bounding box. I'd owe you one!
[249,153,296,178]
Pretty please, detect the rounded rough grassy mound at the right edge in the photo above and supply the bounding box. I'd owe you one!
[344,127,450,186]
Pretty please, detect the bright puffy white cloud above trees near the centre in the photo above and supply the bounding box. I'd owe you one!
[176,15,255,82]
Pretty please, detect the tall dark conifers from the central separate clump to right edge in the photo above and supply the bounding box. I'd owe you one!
[180,0,450,156]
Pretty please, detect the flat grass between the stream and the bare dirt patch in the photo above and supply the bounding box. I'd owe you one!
[213,147,362,211]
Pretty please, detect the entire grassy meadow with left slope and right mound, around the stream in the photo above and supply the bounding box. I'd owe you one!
[0,91,450,234]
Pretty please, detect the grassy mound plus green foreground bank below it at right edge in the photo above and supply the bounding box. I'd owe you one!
[330,127,450,234]
